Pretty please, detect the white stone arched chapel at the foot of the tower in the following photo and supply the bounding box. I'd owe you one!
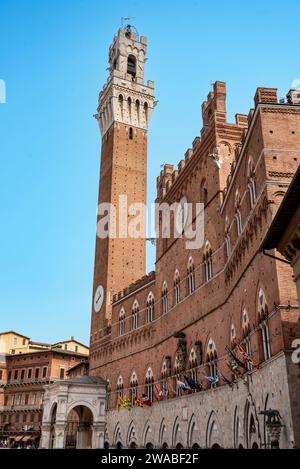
[40,376,107,449]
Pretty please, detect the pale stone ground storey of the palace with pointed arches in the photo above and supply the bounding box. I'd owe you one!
[106,354,300,449]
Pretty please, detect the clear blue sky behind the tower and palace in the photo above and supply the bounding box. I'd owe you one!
[0,0,300,342]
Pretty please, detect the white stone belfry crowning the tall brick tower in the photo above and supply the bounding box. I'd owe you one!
[95,26,155,136]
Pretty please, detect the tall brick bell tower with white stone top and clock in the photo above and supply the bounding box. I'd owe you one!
[91,26,154,349]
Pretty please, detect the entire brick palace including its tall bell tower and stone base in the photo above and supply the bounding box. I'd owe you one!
[90,28,300,448]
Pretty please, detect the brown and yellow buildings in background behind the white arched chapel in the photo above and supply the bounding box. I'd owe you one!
[0,332,88,446]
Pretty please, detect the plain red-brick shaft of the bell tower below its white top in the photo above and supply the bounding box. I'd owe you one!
[91,124,147,354]
